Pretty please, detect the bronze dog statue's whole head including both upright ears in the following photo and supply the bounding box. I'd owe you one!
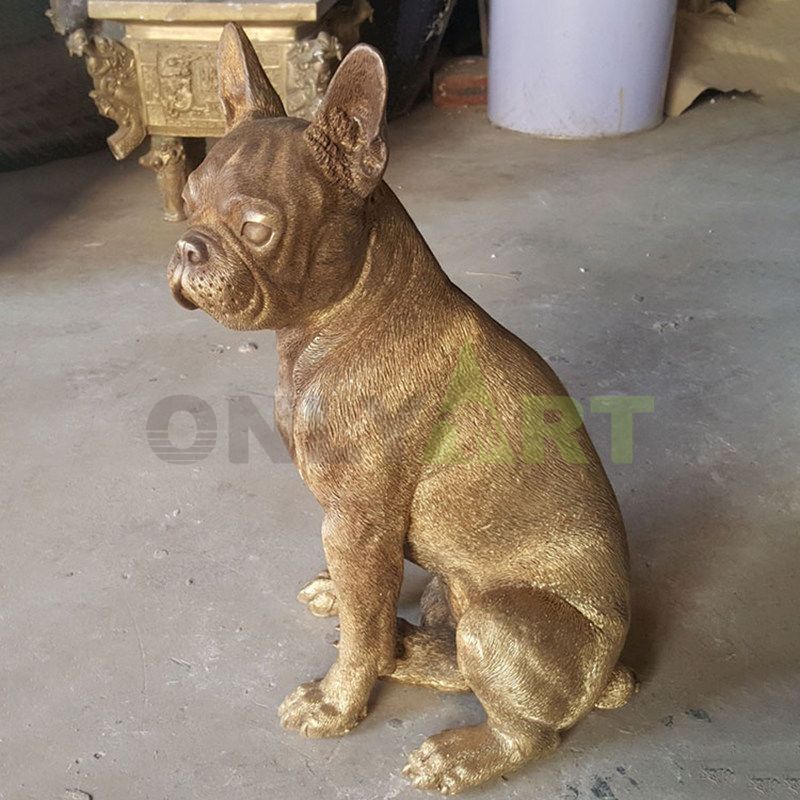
[169,23,388,330]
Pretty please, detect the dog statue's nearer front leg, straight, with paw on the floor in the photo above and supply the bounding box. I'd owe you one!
[280,507,405,736]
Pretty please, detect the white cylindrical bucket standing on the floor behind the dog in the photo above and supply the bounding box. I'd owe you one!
[489,0,677,139]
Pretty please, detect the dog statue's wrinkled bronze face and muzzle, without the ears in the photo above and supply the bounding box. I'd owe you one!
[170,118,363,330]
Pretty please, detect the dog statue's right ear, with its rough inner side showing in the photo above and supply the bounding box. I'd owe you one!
[305,44,389,197]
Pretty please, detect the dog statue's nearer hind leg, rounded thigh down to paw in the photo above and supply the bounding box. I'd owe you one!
[404,587,625,794]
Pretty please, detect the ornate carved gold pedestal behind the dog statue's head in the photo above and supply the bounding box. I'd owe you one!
[61,0,370,221]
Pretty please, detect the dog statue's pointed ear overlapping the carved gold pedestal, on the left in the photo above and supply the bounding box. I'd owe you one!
[217,22,286,131]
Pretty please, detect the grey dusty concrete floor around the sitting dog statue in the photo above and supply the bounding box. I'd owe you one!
[0,98,800,800]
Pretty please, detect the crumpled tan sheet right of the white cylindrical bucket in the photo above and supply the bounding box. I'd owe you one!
[666,0,800,116]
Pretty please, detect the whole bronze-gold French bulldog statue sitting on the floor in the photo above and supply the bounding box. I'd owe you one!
[169,24,635,794]
